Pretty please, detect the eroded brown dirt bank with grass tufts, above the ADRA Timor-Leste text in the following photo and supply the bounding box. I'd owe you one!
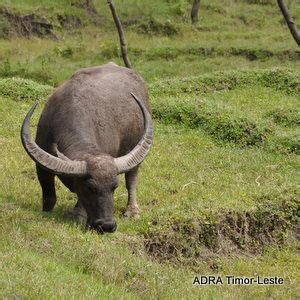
[144,196,299,268]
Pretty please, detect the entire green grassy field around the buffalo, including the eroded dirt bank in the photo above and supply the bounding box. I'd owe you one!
[0,0,300,299]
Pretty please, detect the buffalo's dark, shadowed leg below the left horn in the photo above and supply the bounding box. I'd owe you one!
[36,165,56,211]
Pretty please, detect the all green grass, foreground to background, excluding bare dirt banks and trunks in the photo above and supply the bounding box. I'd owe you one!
[0,0,300,299]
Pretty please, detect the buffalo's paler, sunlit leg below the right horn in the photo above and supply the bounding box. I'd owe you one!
[124,167,140,218]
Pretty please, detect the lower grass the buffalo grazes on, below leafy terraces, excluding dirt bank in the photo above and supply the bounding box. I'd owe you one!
[0,89,297,297]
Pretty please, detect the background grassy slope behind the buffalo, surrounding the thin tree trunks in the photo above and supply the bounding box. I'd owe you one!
[0,0,300,84]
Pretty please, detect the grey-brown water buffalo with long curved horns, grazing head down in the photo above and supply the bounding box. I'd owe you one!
[21,63,153,232]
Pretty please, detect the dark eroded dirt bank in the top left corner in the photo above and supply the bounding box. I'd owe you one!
[0,9,58,40]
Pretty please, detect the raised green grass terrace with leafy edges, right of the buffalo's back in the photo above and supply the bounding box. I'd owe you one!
[151,71,300,153]
